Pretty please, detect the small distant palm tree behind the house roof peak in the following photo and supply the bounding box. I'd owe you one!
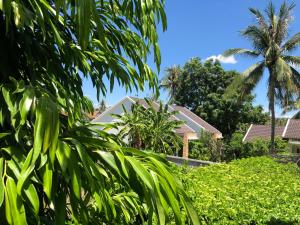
[160,65,182,103]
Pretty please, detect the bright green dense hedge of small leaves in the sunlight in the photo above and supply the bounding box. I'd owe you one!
[175,157,300,224]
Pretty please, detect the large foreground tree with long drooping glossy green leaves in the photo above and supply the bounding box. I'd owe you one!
[0,0,199,225]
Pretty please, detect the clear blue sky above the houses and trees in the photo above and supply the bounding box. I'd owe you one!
[83,0,300,118]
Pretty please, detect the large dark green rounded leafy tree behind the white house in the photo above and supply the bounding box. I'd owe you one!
[169,58,267,138]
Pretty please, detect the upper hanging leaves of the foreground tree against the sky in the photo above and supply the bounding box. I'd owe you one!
[1,0,166,97]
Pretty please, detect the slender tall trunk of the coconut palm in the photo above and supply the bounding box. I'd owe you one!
[268,68,276,154]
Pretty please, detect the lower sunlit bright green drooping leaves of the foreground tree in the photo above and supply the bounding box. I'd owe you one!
[0,82,197,224]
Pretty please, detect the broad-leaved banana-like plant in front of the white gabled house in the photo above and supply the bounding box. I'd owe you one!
[114,99,182,154]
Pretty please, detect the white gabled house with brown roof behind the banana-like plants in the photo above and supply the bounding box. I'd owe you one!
[92,96,222,158]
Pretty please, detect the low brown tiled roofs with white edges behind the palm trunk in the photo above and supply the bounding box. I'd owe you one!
[243,119,300,153]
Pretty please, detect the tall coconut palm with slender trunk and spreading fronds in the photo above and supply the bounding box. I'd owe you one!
[224,2,300,153]
